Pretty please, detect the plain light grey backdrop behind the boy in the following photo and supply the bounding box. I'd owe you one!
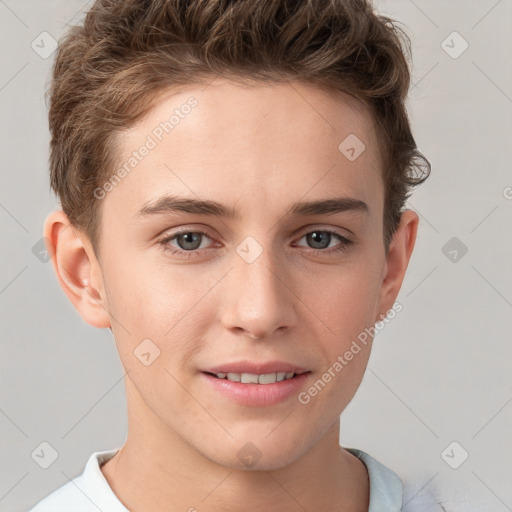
[0,0,512,512]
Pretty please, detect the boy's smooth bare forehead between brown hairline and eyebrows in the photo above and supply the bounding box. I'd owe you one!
[104,79,382,220]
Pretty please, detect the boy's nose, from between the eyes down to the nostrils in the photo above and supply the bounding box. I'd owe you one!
[221,240,297,339]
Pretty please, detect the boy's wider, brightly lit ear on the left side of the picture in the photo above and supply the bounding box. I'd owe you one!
[44,210,110,328]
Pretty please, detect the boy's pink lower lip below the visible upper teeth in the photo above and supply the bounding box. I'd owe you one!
[203,372,311,407]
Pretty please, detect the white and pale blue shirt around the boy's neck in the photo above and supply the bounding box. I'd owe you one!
[28,448,443,512]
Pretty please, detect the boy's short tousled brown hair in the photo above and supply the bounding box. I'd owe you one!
[47,0,430,254]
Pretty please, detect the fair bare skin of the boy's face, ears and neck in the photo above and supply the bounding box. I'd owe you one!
[44,79,419,512]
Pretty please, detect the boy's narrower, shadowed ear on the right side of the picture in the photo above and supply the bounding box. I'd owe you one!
[375,210,419,322]
